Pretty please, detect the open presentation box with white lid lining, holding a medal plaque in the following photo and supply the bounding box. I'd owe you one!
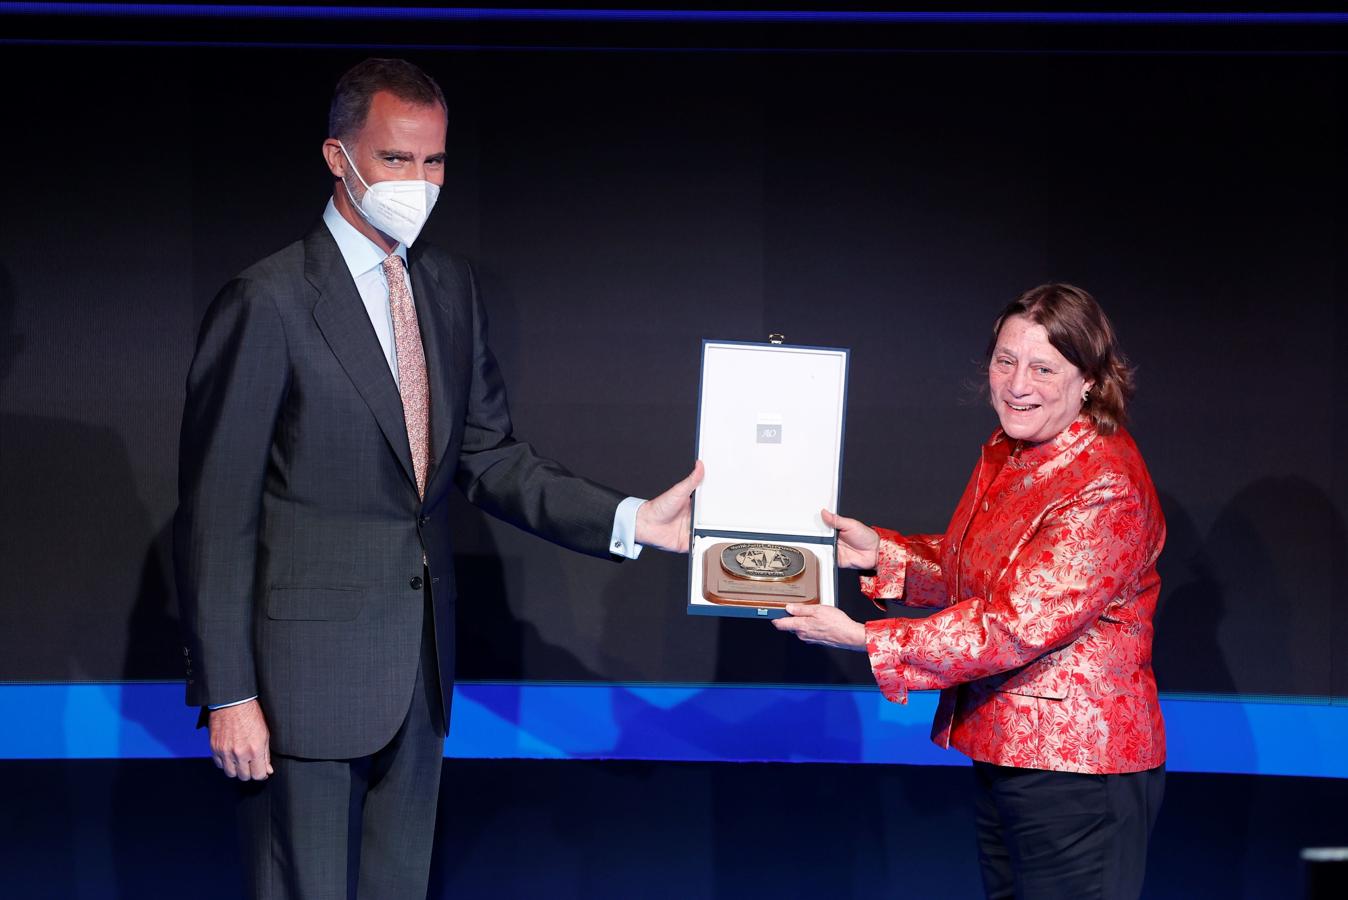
[687,341,848,618]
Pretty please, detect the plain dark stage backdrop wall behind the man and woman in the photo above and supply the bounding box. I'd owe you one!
[0,28,1348,697]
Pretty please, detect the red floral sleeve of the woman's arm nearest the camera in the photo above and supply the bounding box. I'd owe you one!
[865,478,1154,703]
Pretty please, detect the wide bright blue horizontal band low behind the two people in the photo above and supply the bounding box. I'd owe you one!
[0,682,1348,777]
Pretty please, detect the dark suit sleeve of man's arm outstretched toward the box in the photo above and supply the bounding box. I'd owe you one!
[454,268,625,556]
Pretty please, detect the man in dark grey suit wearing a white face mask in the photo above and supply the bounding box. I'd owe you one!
[175,59,701,899]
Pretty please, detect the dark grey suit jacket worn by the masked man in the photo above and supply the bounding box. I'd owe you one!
[174,222,621,759]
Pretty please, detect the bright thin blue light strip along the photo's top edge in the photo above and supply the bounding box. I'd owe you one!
[0,3,1348,26]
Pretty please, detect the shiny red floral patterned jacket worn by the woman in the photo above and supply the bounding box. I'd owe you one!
[861,416,1166,773]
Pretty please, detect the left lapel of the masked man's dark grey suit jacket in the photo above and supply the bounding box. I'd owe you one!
[305,224,415,486]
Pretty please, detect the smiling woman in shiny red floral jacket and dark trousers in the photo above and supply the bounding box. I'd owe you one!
[775,284,1166,899]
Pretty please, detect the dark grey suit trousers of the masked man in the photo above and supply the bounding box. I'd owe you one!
[239,590,445,900]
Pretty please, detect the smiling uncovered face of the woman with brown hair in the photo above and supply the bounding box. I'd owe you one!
[988,315,1092,443]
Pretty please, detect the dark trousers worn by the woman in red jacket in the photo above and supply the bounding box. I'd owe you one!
[973,763,1166,900]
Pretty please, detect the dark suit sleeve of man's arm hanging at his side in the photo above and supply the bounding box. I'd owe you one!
[174,279,288,706]
